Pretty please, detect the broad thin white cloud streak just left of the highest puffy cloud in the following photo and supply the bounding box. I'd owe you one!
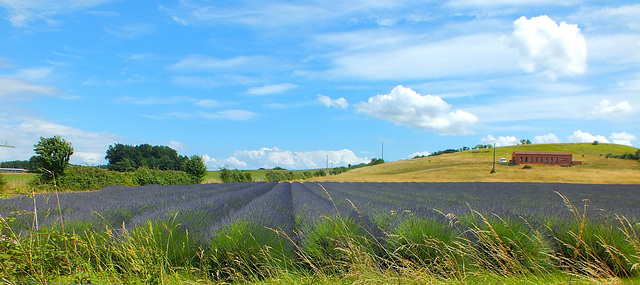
[326,33,517,80]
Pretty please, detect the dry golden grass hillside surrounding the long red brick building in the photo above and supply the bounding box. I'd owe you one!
[316,143,640,184]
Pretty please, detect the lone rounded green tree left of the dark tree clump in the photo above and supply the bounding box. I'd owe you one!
[33,136,73,181]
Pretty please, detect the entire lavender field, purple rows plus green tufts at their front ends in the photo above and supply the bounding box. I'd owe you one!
[0,182,640,282]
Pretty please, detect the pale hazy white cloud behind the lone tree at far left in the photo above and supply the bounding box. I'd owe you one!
[0,116,118,165]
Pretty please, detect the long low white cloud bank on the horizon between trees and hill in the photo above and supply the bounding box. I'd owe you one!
[203,147,369,169]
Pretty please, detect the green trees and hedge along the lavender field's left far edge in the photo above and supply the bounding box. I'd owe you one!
[0,136,207,190]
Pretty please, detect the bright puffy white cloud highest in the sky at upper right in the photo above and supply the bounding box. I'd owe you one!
[503,15,587,79]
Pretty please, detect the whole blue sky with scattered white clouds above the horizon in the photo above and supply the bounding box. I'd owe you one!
[0,0,640,170]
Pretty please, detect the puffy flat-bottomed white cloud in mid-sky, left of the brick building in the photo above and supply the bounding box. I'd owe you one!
[355,85,478,135]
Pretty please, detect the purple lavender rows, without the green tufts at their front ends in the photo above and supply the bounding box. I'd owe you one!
[0,182,640,243]
